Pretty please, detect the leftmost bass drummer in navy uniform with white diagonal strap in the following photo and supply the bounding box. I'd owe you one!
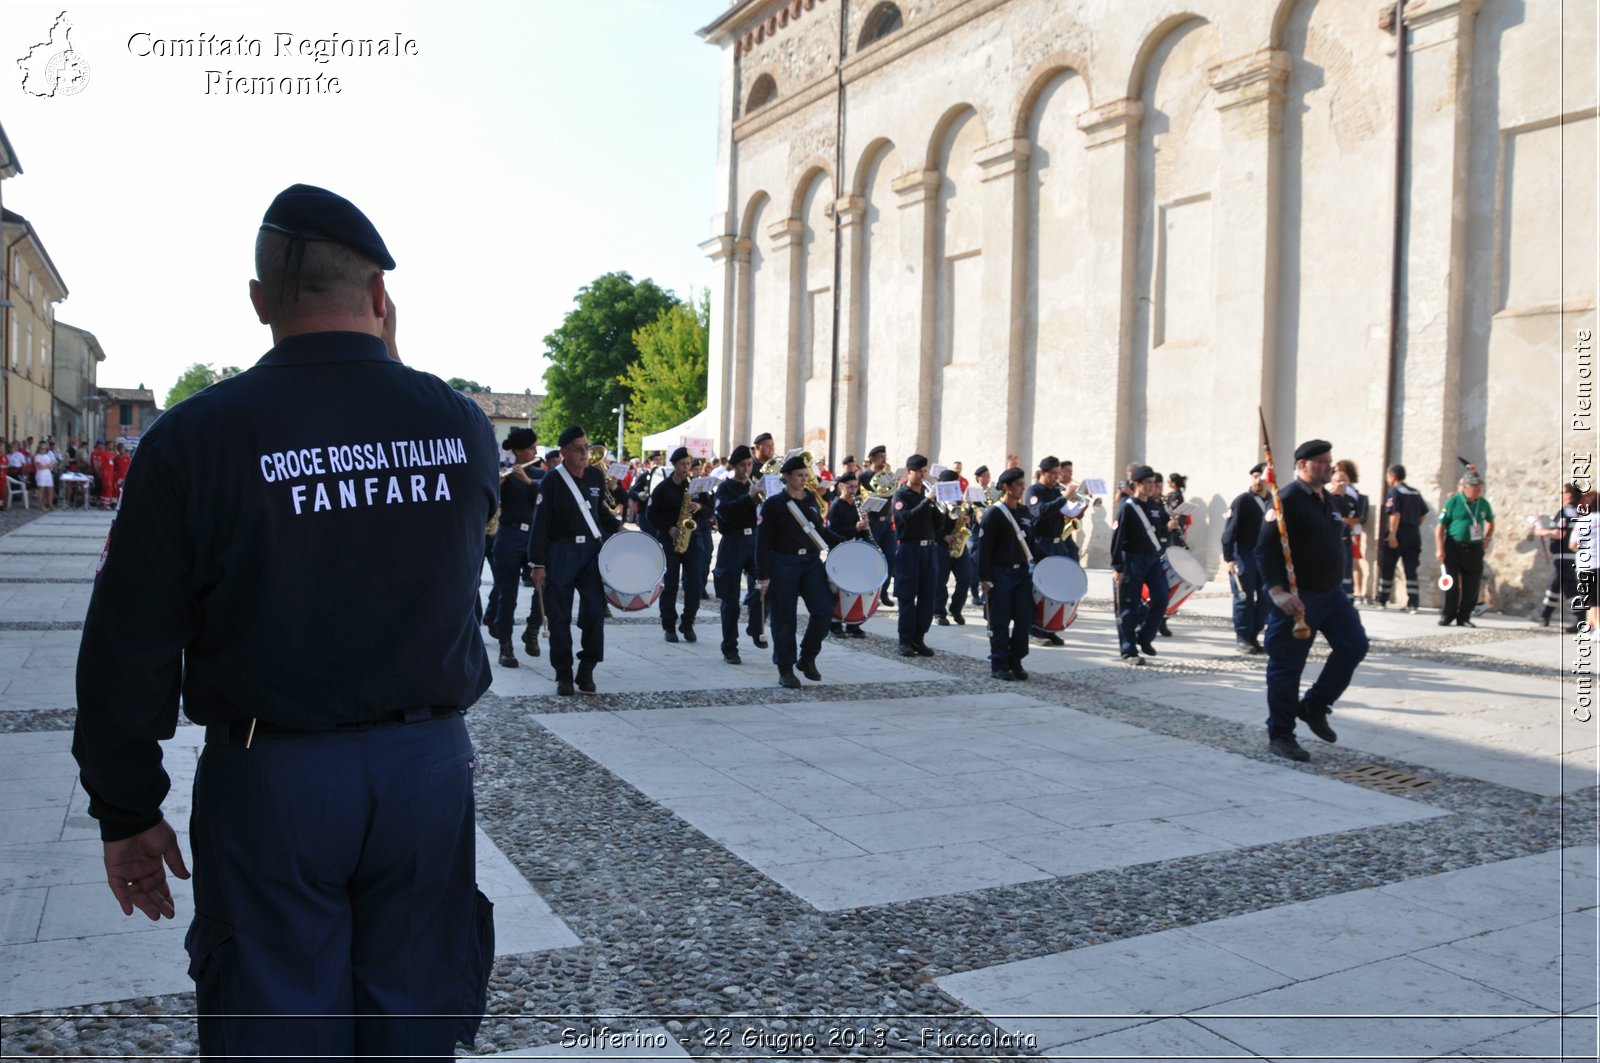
[528,424,622,696]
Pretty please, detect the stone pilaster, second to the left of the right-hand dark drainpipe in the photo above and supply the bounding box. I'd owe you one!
[1081,99,1144,565]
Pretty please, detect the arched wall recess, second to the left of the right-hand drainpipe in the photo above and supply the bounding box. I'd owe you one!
[1130,18,1222,464]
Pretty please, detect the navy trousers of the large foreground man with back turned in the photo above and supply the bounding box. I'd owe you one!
[186,714,494,1060]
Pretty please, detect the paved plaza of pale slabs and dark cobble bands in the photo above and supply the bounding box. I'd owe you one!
[0,512,1600,1060]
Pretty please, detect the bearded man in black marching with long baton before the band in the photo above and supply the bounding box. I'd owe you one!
[1256,439,1366,760]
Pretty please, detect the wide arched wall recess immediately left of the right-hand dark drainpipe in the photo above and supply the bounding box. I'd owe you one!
[1274,0,1394,453]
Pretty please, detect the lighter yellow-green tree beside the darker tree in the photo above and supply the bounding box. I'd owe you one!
[622,291,710,455]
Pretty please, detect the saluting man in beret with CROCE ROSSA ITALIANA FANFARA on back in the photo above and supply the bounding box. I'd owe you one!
[74,184,496,1058]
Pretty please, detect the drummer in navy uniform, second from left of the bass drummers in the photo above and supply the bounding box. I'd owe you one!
[755,455,840,688]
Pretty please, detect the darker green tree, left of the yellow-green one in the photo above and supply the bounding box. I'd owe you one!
[539,272,678,443]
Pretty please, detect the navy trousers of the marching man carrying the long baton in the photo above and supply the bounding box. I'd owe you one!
[1266,591,1366,738]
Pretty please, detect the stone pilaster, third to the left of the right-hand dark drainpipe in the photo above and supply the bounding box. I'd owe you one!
[971,138,1034,455]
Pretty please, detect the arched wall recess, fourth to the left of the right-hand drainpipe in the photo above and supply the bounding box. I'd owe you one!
[918,106,992,461]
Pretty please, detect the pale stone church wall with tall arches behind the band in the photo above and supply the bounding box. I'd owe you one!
[701,0,1597,607]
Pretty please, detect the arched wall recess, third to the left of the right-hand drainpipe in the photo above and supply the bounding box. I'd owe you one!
[1018,69,1094,461]
